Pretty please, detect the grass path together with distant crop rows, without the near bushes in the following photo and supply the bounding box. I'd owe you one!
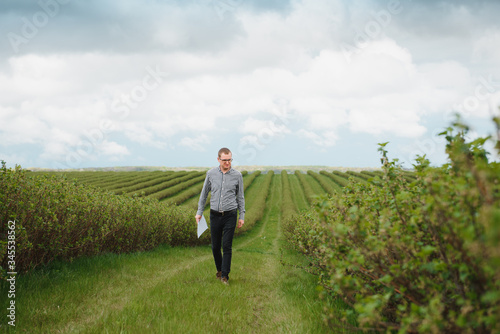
[2,166,375,333]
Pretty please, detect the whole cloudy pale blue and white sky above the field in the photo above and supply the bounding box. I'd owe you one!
[0,0,500,168]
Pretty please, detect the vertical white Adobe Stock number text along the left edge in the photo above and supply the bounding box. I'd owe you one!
[7,220,17,327]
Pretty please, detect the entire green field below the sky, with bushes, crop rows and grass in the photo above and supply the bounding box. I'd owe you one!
[0,124,500,333]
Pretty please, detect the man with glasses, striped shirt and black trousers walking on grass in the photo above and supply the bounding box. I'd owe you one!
[195,147,245,284]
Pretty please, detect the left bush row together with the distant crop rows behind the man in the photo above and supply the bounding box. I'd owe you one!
[0,165,390,282]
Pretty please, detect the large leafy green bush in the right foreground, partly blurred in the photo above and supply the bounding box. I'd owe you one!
[286,119,500,333]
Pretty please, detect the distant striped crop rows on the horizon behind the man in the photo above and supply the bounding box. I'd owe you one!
[43,171,381,213]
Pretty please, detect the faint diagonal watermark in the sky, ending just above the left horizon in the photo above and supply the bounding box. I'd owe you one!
[54,66,168,168]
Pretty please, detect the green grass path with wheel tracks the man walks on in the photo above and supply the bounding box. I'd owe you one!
[1,175,332,333]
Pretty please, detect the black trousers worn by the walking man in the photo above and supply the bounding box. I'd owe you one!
[210,210,238,278]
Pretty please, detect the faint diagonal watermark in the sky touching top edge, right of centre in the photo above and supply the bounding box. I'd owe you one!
[340,0,411,63]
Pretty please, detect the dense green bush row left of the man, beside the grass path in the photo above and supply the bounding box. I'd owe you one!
[0,163,200,272]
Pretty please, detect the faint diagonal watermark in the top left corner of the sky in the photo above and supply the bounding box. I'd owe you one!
[7,0,71,53]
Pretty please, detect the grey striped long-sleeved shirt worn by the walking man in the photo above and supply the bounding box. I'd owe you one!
[196,167,245,219]
